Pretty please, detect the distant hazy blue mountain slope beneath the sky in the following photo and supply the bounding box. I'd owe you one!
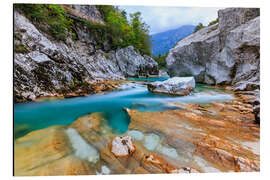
[151,25,195,56]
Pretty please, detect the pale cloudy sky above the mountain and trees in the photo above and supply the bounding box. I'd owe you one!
[119,6,222,34]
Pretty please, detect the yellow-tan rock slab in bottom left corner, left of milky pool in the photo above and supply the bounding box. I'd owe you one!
[14,126,95,176]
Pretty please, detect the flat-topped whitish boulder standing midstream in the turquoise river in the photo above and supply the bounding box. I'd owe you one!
[147,77,195,96]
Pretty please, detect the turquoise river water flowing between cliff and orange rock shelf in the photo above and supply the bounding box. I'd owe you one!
[14,77,233,138]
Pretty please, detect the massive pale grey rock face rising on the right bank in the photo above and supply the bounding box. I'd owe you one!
[166,8,260,86]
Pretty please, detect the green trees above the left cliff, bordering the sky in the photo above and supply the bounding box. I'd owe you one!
[97,5,151,55]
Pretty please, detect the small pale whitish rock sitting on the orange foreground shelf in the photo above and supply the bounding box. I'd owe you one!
[111,136,135,157]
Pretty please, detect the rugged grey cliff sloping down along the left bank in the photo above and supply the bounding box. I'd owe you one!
[14,5,158,102]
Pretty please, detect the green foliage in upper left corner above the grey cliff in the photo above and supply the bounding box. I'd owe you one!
[15,4,73,40]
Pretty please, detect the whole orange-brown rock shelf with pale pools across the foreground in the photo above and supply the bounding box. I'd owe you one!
[14,87,260,176]
